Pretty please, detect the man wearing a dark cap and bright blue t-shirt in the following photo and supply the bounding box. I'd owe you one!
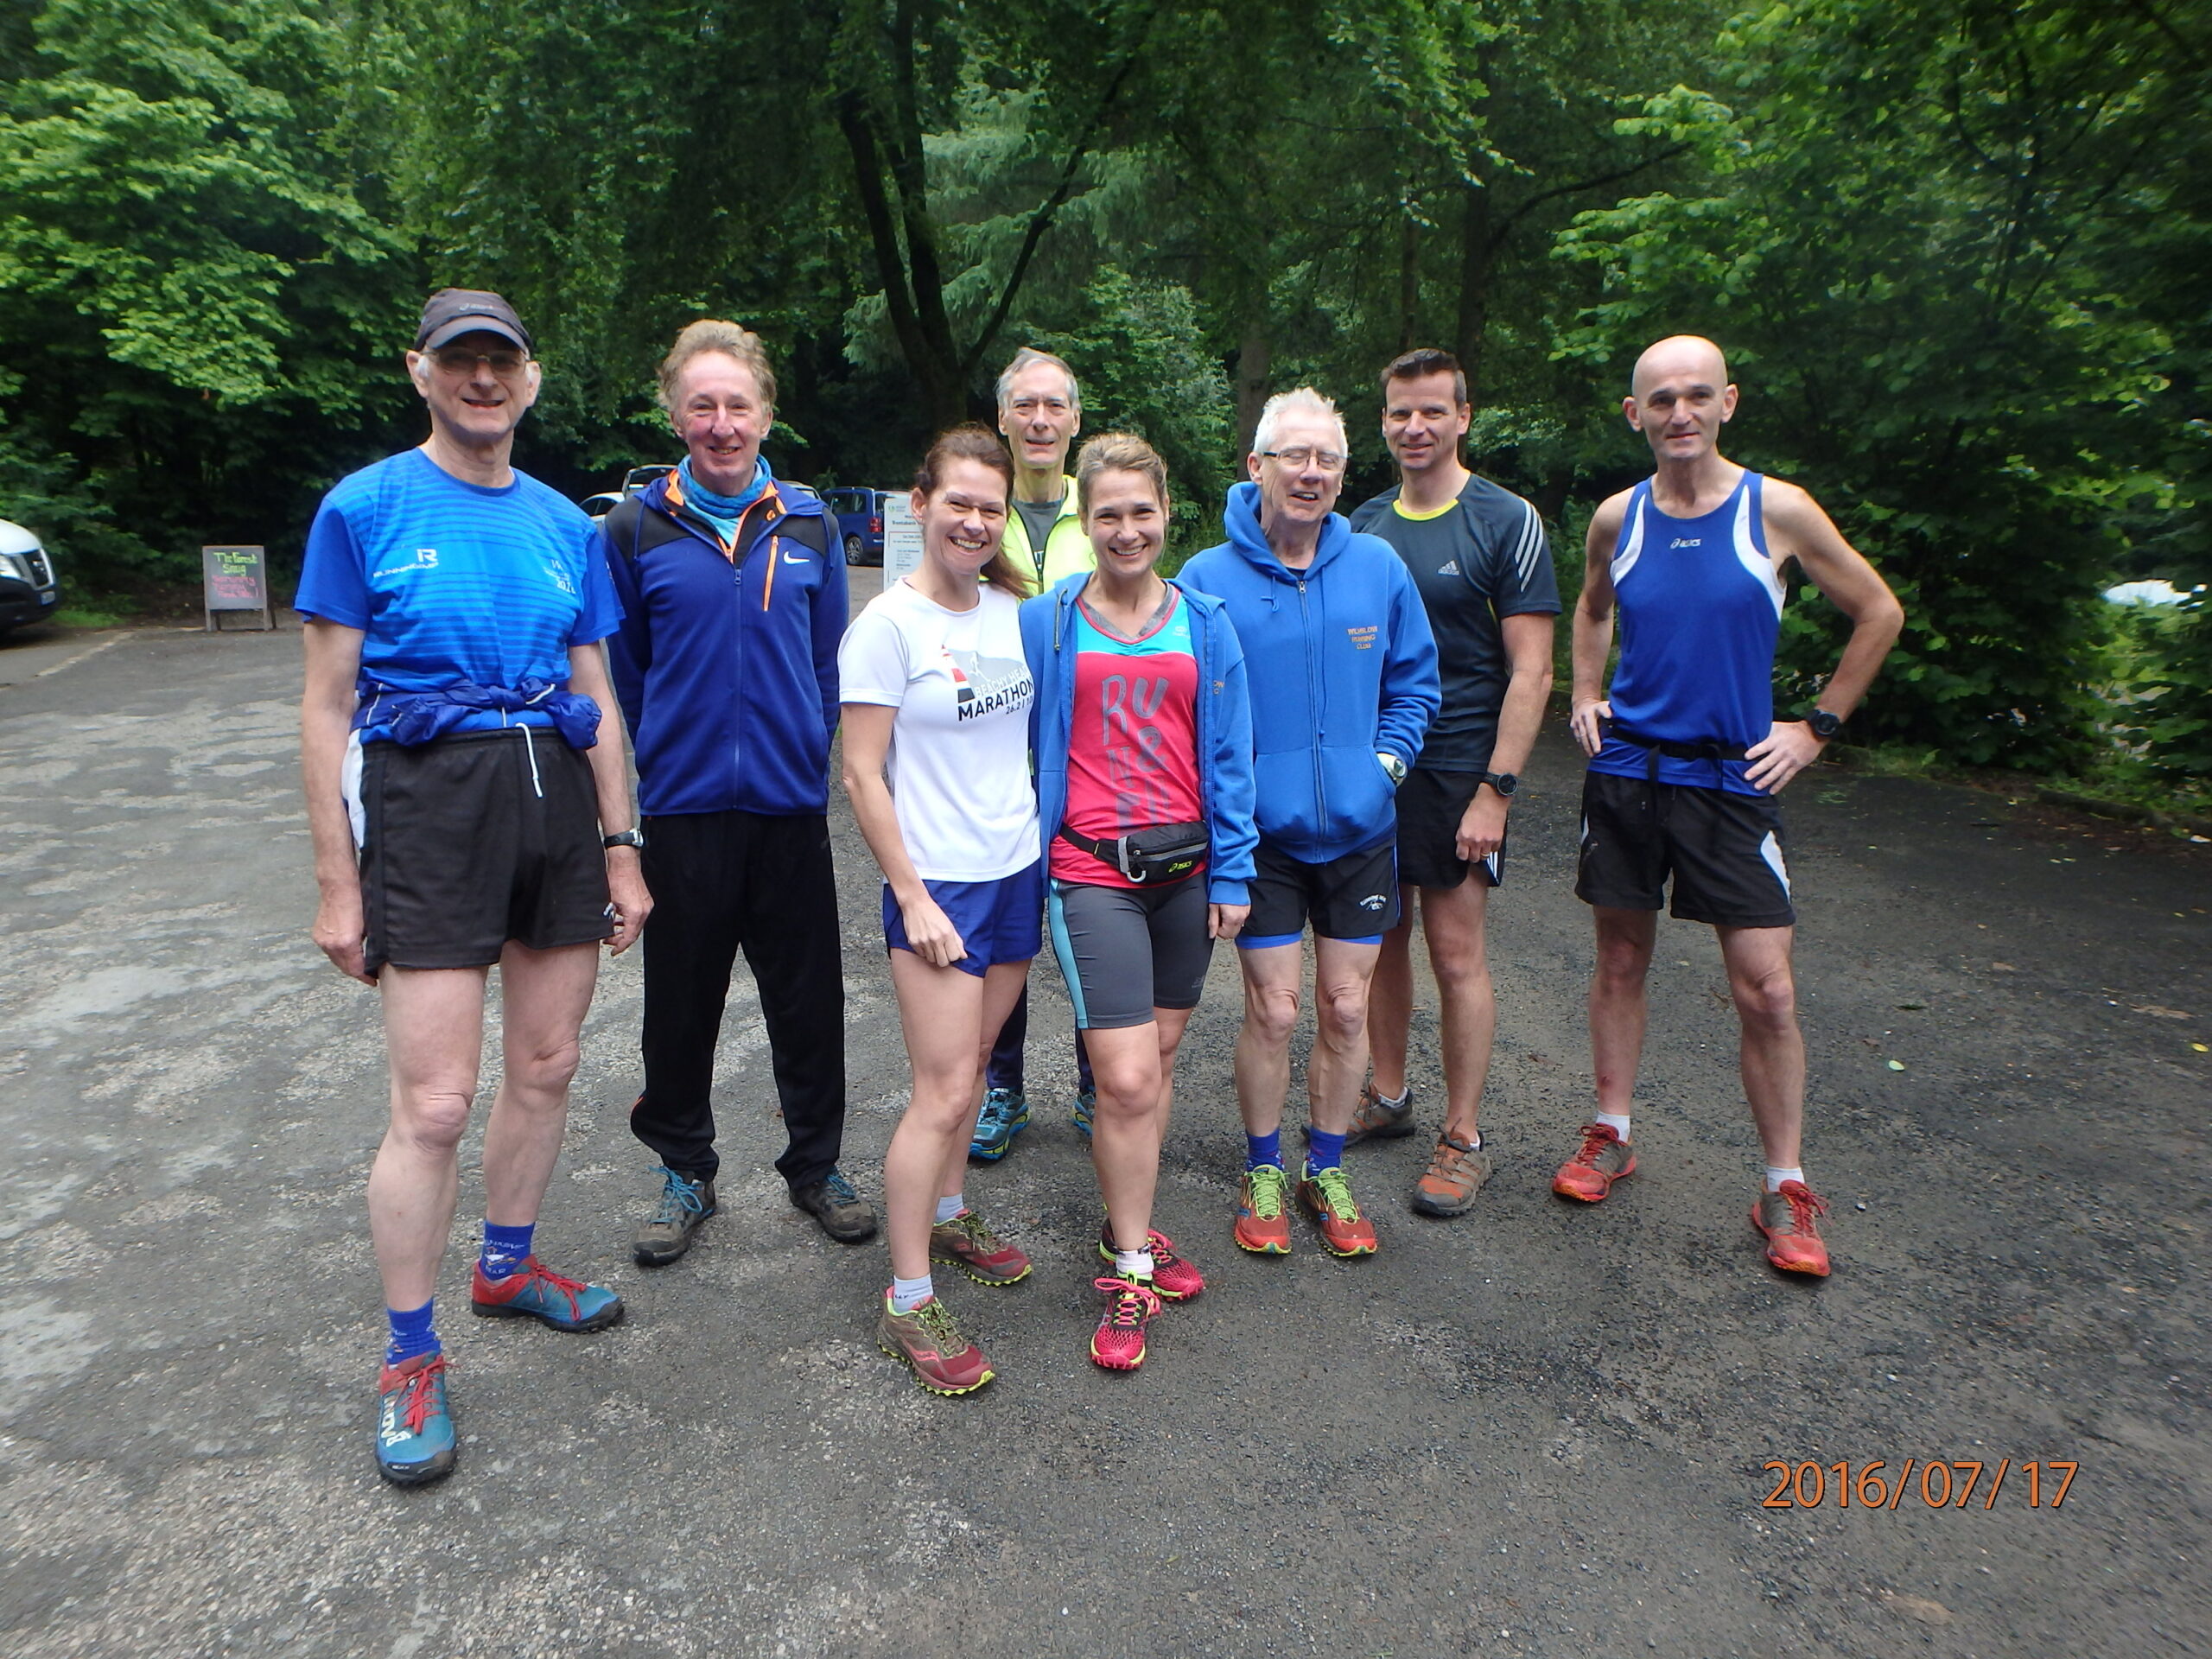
[294,288,652,1486]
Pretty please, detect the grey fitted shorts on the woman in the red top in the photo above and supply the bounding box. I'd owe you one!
[1044,876,1214,1031]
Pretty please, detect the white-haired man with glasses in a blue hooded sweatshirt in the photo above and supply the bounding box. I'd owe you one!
[1181,387,1440,1256]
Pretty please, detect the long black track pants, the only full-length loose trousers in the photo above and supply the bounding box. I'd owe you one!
[631,812,845,1185]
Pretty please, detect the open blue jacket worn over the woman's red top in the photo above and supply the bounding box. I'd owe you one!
[1022,570,1259,905]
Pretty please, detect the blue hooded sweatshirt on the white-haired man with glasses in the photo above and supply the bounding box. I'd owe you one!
[1179,485,1442,865]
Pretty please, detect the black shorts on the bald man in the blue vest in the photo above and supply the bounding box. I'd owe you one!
[1575,772,1796,927]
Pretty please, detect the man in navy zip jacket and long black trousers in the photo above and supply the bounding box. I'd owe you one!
[600,319,876,1268]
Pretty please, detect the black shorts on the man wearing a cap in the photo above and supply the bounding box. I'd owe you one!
[360,726,615,973]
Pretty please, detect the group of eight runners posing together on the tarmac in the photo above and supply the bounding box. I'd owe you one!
[296,289,1903,1484]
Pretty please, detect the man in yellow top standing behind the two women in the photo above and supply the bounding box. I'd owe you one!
[969,345,1097,1164]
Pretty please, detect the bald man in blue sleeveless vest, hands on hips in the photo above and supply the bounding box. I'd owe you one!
[1551,334,1904,1276]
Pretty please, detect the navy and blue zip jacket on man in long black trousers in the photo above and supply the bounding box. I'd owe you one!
[600,478,847,817]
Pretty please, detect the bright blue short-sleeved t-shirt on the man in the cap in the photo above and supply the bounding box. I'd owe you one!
[292,449,621,743]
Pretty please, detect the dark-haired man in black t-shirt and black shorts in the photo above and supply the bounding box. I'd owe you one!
[1351,349,1560,1217]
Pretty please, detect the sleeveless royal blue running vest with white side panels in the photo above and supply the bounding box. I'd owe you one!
[1591,471,1783,794]
